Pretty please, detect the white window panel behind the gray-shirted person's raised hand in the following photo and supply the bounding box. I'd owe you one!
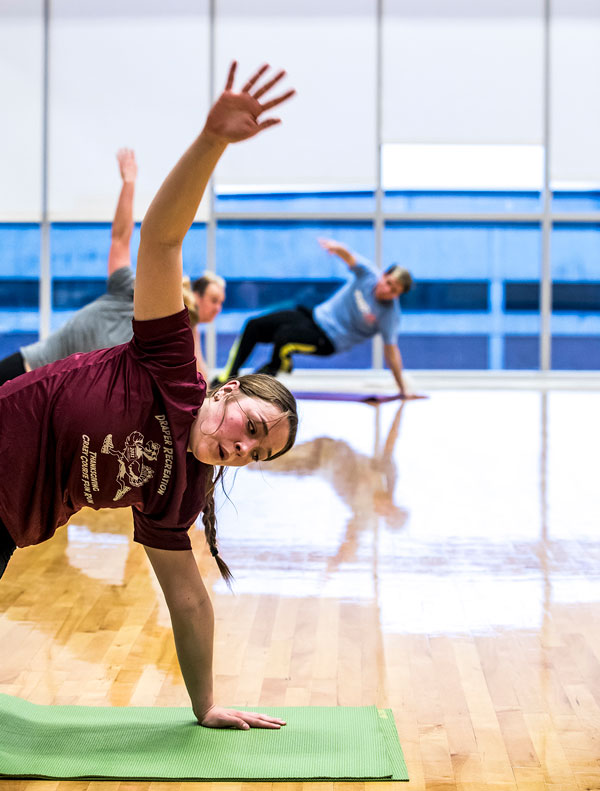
[49,0,209,221]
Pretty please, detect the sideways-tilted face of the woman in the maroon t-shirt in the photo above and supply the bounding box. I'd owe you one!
[189,380,289,467]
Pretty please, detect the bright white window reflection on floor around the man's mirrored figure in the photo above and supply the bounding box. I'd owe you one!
[217,392,600,633]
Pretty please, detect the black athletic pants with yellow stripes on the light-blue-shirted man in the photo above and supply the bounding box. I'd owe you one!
[219,306,335,381]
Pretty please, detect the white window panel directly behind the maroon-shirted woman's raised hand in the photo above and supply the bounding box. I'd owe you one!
[217,0,376,187]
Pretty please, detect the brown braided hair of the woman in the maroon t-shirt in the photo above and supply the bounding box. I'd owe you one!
[202,374,298,587]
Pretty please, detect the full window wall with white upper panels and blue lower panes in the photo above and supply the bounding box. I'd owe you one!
[0,0,600,370]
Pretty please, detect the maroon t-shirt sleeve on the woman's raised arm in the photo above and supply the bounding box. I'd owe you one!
[130,308,197,382]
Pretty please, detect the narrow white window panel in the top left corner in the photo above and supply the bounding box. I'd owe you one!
[0,0,43,222]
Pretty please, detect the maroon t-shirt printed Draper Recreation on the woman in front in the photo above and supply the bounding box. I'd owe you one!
[0,309,209,549]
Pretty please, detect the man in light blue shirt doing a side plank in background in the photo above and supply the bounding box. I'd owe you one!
[214,239,412,395]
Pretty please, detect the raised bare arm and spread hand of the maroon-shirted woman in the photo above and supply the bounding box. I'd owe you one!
[134,62,294,319]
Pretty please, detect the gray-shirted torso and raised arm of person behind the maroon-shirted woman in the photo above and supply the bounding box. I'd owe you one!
[0,148,137,384]
